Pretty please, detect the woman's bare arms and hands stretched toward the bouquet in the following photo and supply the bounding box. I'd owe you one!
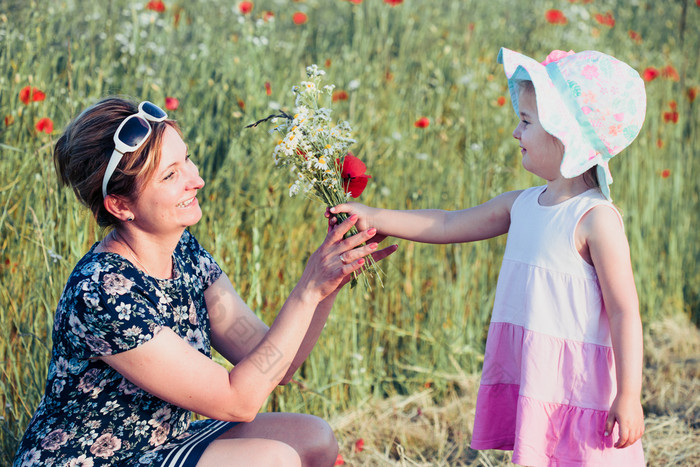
[101,218,396,421]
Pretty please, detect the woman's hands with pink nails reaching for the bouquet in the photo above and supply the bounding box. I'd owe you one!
[299,215,398,302]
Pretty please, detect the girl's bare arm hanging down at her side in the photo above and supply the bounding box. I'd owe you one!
[581,206,644,448]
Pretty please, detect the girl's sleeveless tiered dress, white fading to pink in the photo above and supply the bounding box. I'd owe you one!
[471,186,644,467]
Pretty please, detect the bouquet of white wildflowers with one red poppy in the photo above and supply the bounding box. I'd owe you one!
[247,65,381,288]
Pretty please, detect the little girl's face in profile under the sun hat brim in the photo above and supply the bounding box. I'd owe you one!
[513,87,564,181]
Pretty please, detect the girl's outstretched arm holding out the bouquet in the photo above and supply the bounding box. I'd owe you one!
[327,191,521,243]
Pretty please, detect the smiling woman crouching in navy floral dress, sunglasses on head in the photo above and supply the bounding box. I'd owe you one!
[15,98,396,466]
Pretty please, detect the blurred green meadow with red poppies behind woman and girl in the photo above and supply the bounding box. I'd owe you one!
[0,0,700,465]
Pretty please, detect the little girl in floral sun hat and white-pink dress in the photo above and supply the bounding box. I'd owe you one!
[330,48,646,466]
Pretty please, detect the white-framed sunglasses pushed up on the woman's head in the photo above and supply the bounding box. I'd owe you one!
[102,101,168,199]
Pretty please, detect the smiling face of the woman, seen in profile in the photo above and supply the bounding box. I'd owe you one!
[131,127,204,234]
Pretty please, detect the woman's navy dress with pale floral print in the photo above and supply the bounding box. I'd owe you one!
[14,231,235,467]
